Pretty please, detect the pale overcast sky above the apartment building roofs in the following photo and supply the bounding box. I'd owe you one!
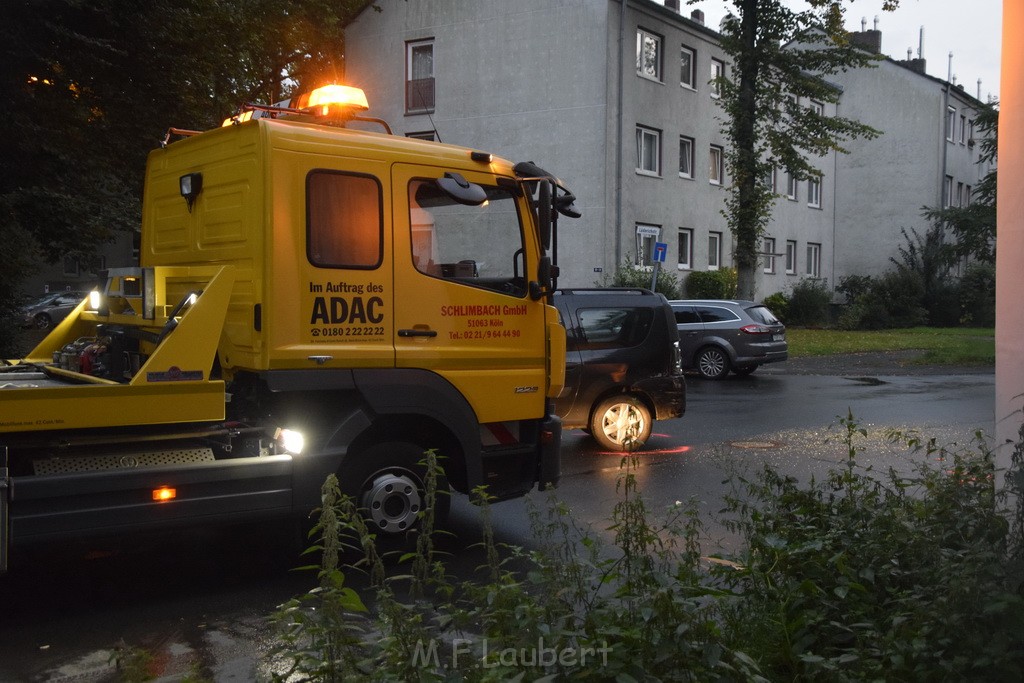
[675,0,1002,101]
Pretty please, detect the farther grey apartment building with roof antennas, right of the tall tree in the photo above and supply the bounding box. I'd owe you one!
[829,30,992,279]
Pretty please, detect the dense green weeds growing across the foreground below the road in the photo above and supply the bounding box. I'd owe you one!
[269,421,1024,681]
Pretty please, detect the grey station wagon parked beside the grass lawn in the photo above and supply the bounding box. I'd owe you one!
[670,299,790,380]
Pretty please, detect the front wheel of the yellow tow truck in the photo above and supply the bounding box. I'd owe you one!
[338,441,452,538]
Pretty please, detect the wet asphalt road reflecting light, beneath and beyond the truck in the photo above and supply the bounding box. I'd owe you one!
[0,364,994,683]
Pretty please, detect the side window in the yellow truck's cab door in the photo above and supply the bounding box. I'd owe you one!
[409,179,526,296]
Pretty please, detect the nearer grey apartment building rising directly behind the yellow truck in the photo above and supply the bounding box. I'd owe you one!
[345,0,836,296]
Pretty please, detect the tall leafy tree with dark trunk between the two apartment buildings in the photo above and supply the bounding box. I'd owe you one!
[717,0,898,299]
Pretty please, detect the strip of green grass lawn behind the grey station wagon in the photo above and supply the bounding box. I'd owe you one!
[785,328,995,366]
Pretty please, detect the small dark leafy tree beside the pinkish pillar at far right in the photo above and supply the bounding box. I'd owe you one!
[922,102,999,264]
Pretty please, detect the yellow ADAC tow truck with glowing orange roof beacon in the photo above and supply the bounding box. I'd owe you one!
[0,85,579,571]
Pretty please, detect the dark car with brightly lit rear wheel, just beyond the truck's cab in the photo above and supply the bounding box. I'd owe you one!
[554,289,686,451]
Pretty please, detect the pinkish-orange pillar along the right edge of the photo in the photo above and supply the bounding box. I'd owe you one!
[995,0,1024,473]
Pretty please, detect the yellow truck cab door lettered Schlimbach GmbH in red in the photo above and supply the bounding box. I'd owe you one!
[392,164,547,423]
